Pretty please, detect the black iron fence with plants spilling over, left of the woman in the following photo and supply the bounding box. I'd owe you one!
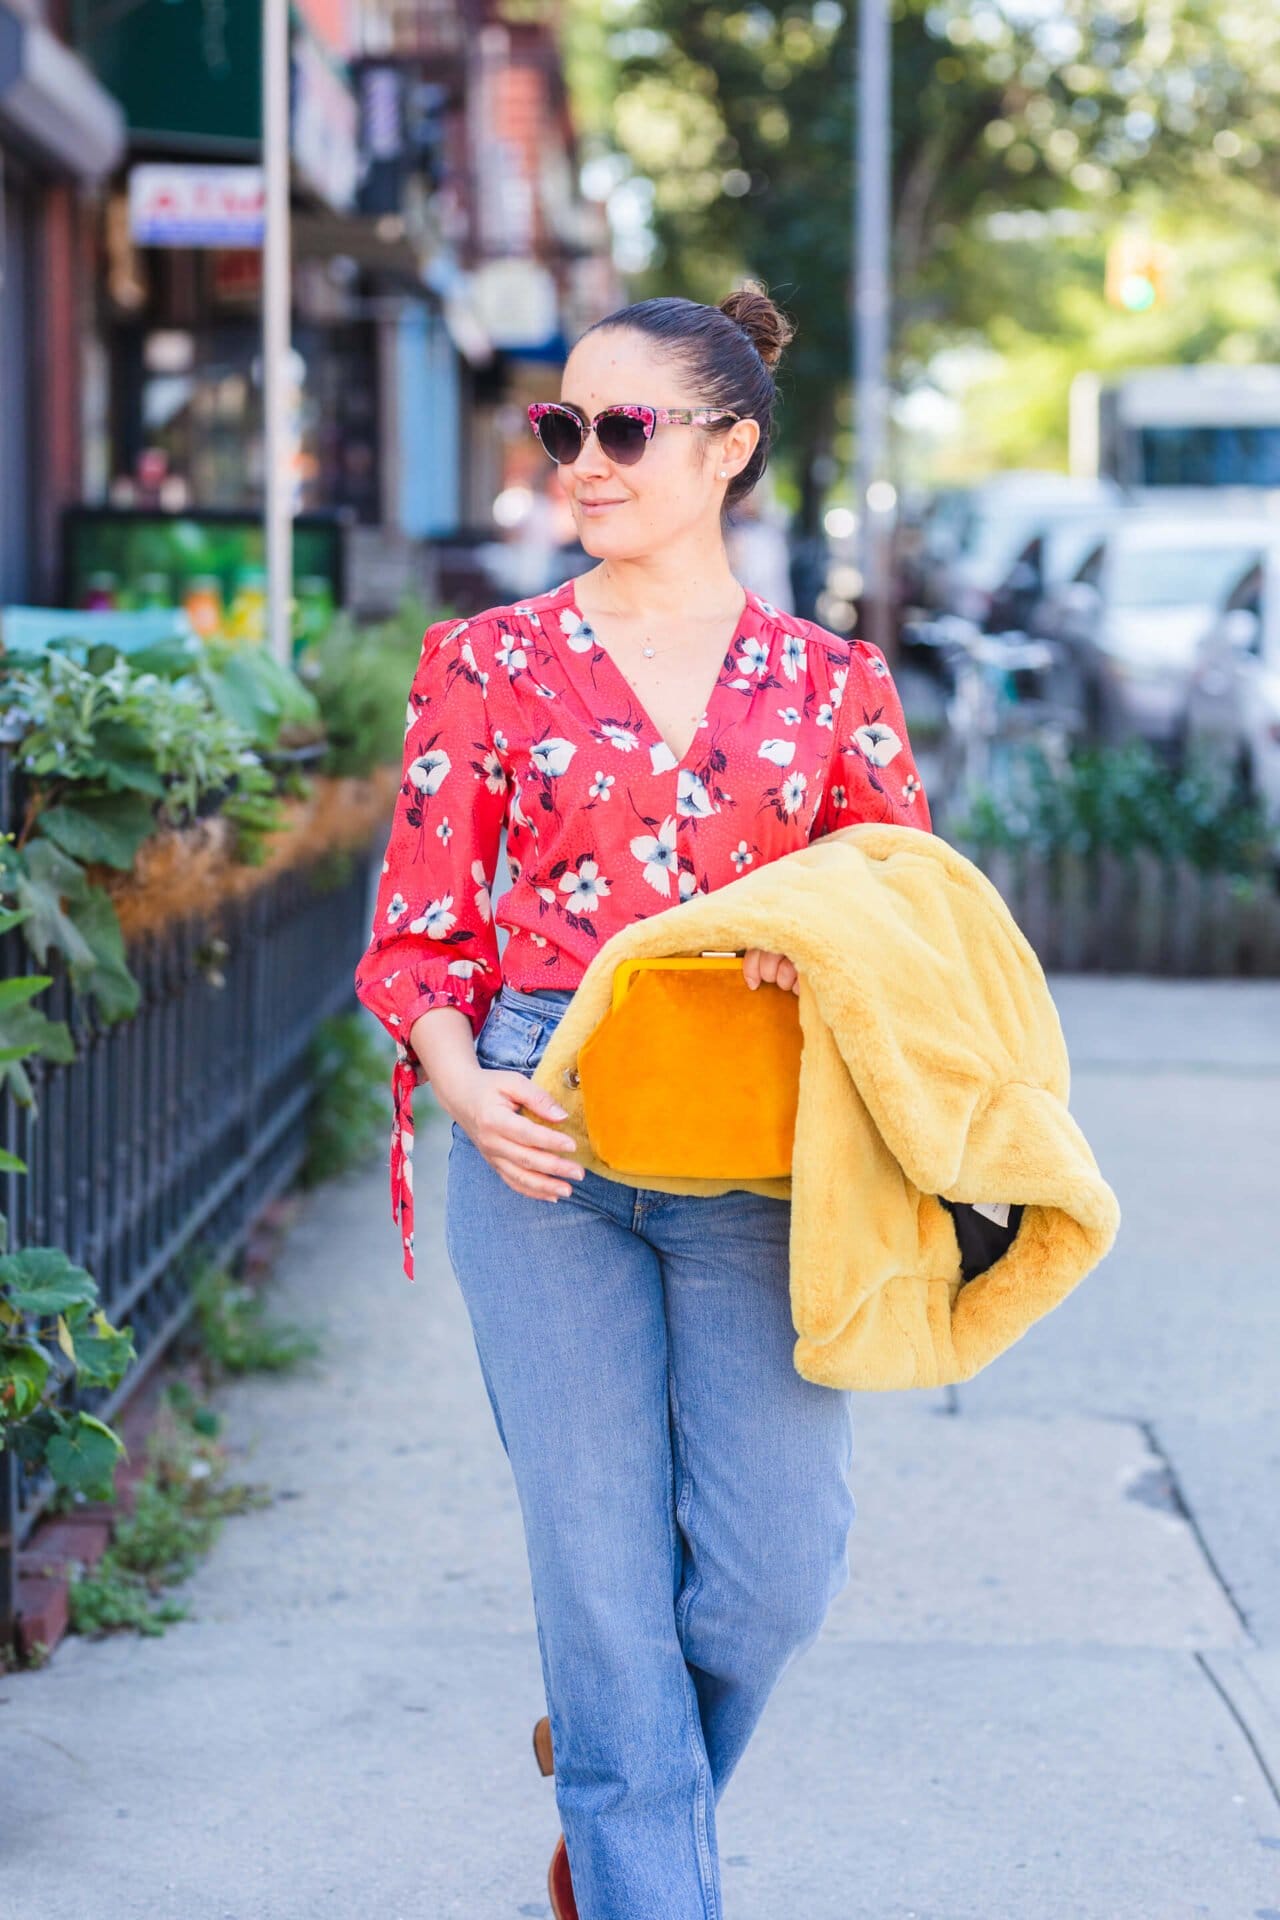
[0,833,372,1638]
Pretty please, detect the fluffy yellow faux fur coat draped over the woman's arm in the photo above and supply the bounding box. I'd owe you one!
[532,822,1119,1388]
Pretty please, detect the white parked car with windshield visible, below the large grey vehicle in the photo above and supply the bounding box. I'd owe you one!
[1031,505,1276,756]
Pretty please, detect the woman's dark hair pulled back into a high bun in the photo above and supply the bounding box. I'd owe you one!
[580,280,794,511]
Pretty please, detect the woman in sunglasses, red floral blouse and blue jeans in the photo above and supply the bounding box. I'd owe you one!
[357,286,931,1920]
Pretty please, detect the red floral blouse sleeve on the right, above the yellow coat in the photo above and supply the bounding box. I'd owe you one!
[810,639,933,839]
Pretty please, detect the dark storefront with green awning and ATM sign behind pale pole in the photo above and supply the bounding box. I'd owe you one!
[81,0,382,524]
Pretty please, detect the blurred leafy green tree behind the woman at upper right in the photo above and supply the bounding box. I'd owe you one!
[566,0,1280,528]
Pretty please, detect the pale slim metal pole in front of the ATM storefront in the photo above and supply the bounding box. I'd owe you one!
[261,0,294,664]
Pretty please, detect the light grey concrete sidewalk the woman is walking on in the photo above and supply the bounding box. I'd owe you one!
[0,977,1280,1920]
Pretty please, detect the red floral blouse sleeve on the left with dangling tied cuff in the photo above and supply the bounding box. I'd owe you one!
[355,620,507,1279]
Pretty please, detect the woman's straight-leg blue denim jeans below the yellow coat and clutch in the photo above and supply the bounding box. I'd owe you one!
[445,985,856,1920]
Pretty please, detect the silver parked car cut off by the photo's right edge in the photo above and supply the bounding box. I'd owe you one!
[1186,538,1280,839]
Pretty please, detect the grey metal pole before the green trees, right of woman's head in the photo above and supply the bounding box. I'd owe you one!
[854,0,890,653]
